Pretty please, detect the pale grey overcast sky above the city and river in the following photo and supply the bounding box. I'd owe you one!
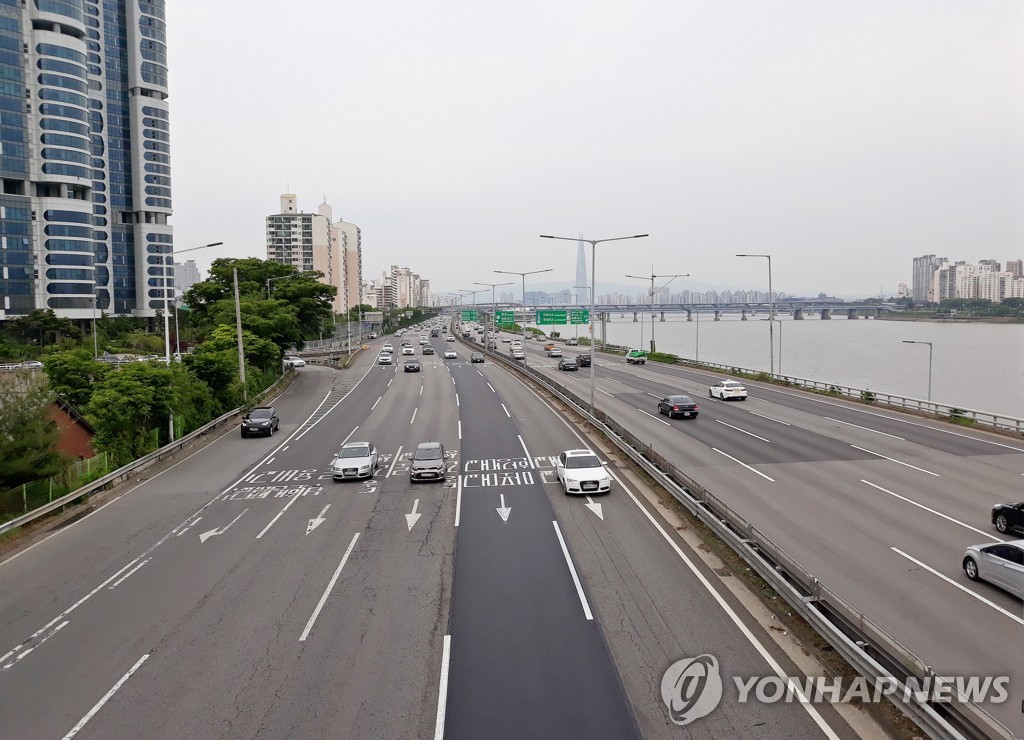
[167,0,1024,300]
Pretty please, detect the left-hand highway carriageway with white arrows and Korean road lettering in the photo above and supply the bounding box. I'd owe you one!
[0,329,865,738]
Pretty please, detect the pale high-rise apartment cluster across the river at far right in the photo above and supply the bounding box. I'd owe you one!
[910,255,1024,303]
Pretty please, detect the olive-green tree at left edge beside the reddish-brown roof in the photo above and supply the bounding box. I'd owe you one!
[0,374,66,490]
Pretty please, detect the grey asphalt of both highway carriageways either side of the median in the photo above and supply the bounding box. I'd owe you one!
[0,327,1024,738]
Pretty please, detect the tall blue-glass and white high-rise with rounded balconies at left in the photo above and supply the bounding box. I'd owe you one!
[0,0,174,325]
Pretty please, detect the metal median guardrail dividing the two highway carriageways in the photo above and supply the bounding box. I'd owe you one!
[466,333,1014,740]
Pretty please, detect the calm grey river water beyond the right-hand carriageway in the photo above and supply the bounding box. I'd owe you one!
[544,313,1024,418]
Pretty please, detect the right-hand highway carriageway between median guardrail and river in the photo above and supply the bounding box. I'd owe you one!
[499,333,1024,736]
